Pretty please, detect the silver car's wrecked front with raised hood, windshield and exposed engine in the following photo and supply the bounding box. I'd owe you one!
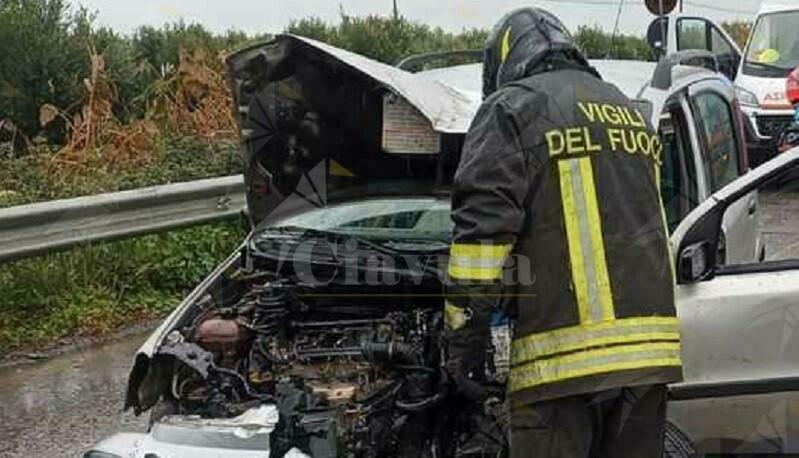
[115,36,507,458]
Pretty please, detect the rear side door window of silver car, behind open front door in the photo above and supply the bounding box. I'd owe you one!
[693,92,741,191]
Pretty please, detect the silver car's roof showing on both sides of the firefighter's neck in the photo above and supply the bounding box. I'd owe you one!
[417,60,657,99]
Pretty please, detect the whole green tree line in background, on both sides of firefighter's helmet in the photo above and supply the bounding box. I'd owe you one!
[0,0,651,143]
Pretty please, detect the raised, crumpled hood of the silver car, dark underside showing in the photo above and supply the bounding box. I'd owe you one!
[228,35,480,223]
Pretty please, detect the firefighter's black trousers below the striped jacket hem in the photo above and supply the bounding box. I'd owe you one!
[511,385,666,458]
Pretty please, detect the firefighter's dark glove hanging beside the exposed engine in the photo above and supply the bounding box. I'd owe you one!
[444,303,491,403]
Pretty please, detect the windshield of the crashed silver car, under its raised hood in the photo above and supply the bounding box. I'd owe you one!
[259,198,452,241]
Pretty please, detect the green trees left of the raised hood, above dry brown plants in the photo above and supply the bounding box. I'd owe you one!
[0,0,255,142]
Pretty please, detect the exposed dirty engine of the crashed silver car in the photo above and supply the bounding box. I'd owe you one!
[154,254,507,458]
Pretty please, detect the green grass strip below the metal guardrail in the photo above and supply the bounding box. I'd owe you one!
[0,222,244,355]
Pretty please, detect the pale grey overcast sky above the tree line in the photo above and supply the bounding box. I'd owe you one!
[71,0,760,34]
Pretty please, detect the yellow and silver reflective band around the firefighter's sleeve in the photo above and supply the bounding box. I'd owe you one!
[449,243,513,280]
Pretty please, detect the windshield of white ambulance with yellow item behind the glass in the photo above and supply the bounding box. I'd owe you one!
[744,11,799,78]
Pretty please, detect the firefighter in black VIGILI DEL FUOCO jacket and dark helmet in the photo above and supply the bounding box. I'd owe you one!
[444,8,682,458]
